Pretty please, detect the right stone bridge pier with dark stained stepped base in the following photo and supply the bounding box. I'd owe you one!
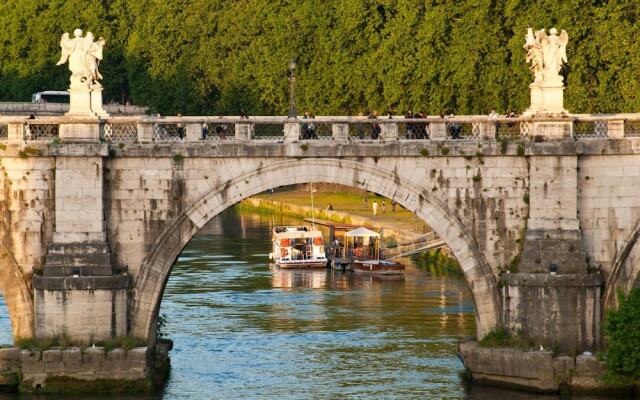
[501,156,602,352]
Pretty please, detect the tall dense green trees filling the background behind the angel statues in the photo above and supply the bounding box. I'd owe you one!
[0,0,640,114]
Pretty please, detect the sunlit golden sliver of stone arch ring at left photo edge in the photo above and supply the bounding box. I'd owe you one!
[0,240,33,339]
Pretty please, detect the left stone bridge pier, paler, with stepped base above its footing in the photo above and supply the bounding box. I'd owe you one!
[33,124,129,343]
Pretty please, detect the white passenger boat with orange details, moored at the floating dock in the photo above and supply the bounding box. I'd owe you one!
[269,226,327,268]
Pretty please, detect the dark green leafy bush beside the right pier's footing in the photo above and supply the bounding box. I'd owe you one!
[604,289,640,382]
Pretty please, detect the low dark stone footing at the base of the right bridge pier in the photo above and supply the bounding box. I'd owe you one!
[459,341,632,393]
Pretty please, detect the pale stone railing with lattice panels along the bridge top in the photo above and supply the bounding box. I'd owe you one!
[0,114,640,143]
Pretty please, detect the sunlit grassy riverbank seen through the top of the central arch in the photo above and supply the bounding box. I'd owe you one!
[239,191,431,243]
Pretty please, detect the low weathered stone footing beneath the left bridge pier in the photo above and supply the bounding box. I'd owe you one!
[0,347,159,392]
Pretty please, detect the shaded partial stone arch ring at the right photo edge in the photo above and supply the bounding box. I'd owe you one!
[603,221,640,310]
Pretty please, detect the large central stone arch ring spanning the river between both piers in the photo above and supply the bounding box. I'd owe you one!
[130,158,501,338]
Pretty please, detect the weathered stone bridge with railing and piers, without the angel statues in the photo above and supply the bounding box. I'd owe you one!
[0,114,640,349]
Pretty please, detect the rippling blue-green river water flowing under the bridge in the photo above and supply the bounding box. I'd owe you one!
[0,210,608,400]
